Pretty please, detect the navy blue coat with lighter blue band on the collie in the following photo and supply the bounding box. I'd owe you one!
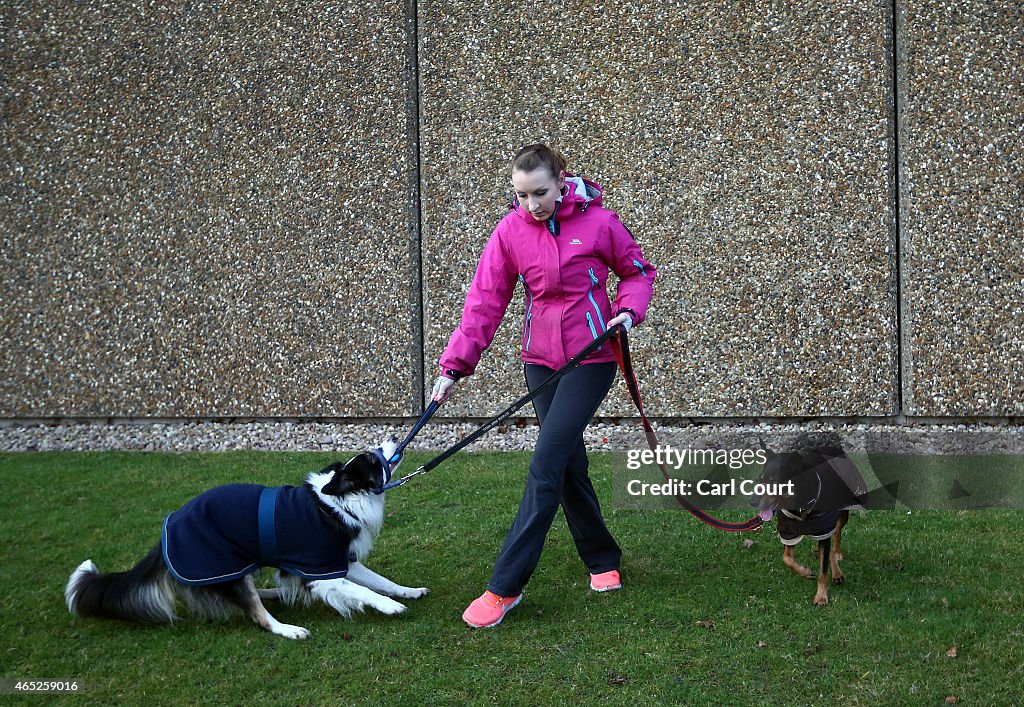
[160,484,350,584]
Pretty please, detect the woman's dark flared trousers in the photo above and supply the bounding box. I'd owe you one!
[487,363,622,596]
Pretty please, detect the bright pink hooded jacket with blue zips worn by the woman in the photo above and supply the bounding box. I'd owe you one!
[438,175,656,376]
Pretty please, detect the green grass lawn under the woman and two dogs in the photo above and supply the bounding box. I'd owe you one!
[0,453,1024,705]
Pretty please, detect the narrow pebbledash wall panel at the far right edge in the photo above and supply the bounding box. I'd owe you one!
[897,0,1024,417]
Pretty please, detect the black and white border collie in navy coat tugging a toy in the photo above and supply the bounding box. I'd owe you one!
[65,439,429,638]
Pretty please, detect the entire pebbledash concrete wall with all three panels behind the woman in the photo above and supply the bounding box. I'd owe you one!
[0,0,1024,418]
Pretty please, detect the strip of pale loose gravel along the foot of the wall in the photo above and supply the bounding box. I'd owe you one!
[0,418,1024,454]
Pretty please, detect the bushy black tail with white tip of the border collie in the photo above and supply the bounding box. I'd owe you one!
[65,545,177,624]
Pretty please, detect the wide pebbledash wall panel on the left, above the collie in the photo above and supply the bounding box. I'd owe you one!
[0,0,422,417]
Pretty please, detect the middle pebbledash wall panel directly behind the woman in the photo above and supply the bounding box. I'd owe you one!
[419,0,898,416]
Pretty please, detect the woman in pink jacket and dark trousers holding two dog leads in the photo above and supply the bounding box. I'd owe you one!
[432,144,656,628]
